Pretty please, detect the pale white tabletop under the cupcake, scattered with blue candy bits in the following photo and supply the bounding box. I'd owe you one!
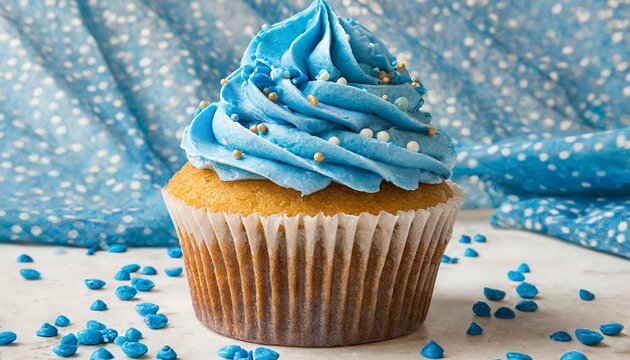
[0,211,630,360]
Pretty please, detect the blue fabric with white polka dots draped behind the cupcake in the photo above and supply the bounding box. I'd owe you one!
[0,0,630,257]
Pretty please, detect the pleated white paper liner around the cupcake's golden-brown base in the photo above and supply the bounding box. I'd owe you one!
[163,182,463,346]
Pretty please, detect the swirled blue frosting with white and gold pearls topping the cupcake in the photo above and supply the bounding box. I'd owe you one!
[182,0,455,195]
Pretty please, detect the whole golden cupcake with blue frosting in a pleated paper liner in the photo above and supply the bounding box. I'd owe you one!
[163,0,463,346]
